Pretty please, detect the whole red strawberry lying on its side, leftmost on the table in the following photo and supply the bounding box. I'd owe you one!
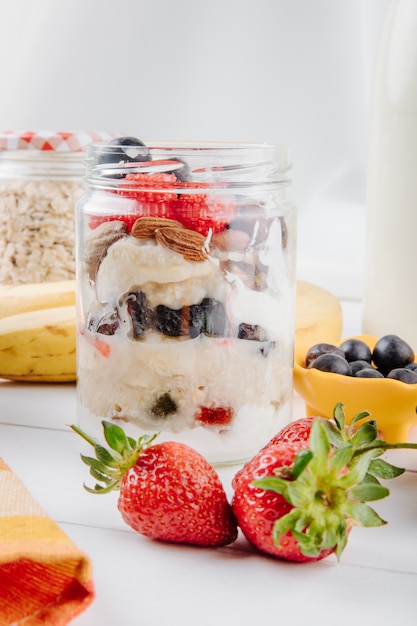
[72,422,237,546]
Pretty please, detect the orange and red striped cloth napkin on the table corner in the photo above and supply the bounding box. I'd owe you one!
[0,459,94,626]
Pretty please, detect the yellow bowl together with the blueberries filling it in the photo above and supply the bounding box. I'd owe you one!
[294,335,417,443]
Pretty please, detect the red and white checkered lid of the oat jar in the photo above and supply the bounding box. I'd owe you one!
[0,130,118,152]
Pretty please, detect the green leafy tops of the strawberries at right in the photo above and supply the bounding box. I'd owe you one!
[253,404,408,559]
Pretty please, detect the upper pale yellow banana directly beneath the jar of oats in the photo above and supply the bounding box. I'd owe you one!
[0,280,75,319]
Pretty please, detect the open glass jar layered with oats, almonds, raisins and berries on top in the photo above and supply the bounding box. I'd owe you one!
[77,137,296,464]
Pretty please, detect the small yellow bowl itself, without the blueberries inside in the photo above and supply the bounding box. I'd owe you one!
[294,335,417,443]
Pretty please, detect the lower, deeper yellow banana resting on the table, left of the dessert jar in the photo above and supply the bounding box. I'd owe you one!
[0,305,76,382]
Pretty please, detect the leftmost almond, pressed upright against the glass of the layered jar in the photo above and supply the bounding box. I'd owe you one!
[84,220,129,280]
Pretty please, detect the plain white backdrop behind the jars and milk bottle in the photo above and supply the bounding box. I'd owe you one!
[0,0,388,298]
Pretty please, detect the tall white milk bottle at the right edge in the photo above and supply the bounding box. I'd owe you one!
[363,0,417,351]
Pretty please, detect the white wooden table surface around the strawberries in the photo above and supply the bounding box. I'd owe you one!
[0,303,417,626]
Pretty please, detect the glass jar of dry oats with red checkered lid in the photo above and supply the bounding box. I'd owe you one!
[0,130,115,285]
